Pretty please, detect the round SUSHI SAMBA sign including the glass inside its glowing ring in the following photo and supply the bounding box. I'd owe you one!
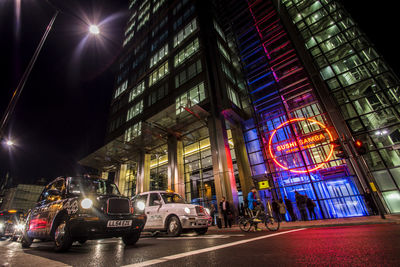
[268,118,334,173]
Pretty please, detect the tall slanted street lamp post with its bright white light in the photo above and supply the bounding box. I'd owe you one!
[0,1,100,142]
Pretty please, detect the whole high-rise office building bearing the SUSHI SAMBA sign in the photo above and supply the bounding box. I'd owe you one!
[81,0,400,218]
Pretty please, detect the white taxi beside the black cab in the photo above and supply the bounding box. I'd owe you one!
[132,191,211,236]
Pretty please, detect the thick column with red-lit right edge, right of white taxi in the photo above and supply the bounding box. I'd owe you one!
[208,115,239,216]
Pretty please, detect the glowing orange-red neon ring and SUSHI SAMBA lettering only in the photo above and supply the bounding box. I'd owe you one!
[268,118,333,173]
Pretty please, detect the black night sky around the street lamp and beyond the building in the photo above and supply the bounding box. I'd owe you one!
[0,0,400,186]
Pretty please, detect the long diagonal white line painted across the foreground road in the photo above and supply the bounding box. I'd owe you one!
[123,228,306,267]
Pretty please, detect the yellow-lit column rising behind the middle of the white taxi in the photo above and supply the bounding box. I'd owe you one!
[168,135,185,197]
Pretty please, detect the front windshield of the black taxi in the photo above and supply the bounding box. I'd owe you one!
[68,177,120,195]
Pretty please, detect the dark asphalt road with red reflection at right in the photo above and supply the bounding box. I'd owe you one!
[0,224,400,267]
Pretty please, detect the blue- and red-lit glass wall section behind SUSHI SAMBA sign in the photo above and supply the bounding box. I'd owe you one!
[234,1,366,218]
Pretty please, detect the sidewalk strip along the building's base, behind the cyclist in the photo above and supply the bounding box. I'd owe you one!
[209,214,400,231]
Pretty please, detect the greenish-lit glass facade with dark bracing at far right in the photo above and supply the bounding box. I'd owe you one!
[281,0,400,212]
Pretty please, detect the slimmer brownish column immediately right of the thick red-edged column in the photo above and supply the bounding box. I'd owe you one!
[231,124,253,199]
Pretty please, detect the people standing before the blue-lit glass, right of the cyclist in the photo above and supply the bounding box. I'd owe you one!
[272,191,318,221]
